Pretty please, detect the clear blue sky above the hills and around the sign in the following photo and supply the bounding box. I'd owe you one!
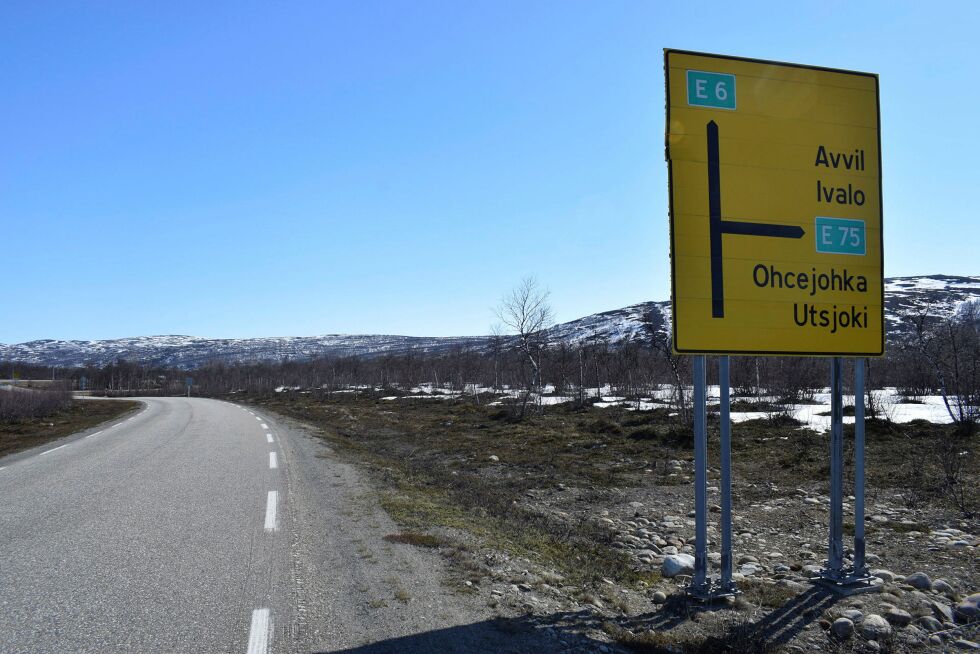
[0,0,980,343]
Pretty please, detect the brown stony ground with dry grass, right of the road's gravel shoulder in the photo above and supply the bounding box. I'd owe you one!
[247,393,980,651]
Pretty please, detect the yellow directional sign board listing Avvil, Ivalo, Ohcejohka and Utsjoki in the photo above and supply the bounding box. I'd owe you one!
[664,50,885,356]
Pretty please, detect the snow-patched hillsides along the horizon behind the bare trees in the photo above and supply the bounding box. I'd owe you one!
[0,275,980,368]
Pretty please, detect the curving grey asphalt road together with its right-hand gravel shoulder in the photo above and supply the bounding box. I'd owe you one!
[0,398,552,654]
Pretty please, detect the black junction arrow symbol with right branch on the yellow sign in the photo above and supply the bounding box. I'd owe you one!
[708,120,805,318]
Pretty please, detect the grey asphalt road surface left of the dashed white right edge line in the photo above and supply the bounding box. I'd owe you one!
[0,399,289,652]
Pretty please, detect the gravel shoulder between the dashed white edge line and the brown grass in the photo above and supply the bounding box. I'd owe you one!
[276,418,568,654]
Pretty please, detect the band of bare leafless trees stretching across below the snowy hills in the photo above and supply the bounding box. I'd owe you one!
[0,294,980,425]
